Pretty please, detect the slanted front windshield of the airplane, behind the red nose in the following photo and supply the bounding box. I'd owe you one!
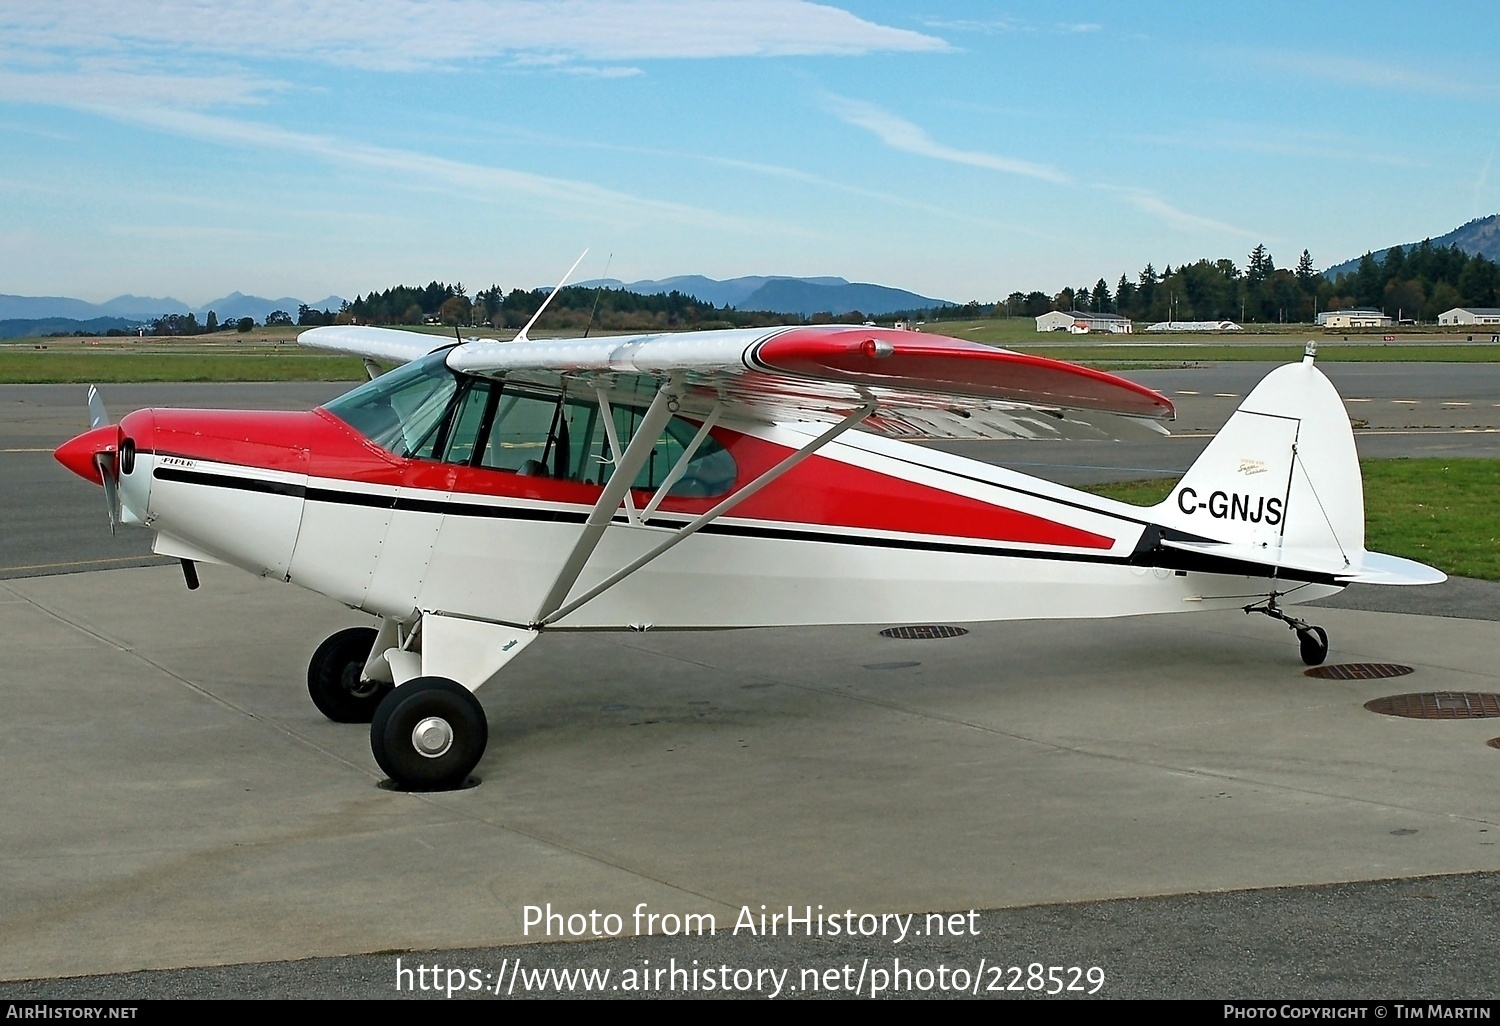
[324,350,459,456]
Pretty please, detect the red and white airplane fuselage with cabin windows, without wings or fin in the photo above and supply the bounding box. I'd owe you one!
[59,364,1338,629]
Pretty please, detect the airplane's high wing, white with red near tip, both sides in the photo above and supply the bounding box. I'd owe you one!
[299,326,1173,438]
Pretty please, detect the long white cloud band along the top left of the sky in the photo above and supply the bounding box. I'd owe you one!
[0,0,948,69]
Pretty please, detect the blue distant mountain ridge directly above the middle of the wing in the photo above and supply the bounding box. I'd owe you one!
[579,275,951,317]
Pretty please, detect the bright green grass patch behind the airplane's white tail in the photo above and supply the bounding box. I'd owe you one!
[1086,459,1500,581]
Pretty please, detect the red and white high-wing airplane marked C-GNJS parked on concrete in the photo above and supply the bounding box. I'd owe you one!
[57,326,1443,789]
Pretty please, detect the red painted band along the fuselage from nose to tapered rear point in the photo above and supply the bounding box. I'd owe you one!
[138,410,1113,549]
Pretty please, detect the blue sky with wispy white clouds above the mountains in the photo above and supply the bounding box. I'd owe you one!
[0,0,1500,303]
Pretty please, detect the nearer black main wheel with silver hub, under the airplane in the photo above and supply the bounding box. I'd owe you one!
[371,677,489,791]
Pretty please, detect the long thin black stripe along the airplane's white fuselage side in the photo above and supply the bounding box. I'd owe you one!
[153,467,1337,584]
